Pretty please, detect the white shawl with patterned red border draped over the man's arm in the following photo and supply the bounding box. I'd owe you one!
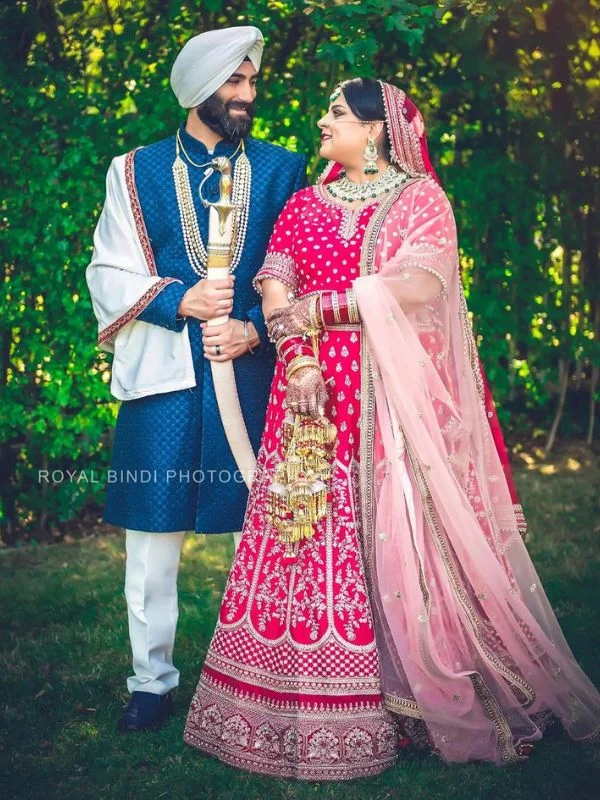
[86,152,196,400]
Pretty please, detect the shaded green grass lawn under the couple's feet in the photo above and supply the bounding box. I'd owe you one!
[0,450,600,800]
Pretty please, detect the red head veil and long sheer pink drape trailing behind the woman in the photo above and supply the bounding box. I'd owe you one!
[344,83,600,763]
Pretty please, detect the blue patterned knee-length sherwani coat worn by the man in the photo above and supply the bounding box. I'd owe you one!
[104,126,306,533]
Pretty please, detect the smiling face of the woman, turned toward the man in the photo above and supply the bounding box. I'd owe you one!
[317,92,371,167]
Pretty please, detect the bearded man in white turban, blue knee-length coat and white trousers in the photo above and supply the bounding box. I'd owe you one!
[86,26,305,731]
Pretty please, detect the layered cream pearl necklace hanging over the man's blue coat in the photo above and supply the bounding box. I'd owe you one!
[173,131,252,278]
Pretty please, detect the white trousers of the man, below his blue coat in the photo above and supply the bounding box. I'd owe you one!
[125,529,240,694]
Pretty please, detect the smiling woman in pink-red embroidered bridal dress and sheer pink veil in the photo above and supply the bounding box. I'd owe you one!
[185,79,600,780]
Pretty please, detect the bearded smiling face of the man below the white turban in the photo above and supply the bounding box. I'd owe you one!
[196,60,258,142]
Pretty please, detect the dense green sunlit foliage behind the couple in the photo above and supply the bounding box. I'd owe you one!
[0,0,600,541]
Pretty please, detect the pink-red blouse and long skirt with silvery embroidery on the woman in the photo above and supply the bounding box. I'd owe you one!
[185,187,397,780]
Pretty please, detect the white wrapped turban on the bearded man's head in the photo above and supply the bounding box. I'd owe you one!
[171,25,264,108]
